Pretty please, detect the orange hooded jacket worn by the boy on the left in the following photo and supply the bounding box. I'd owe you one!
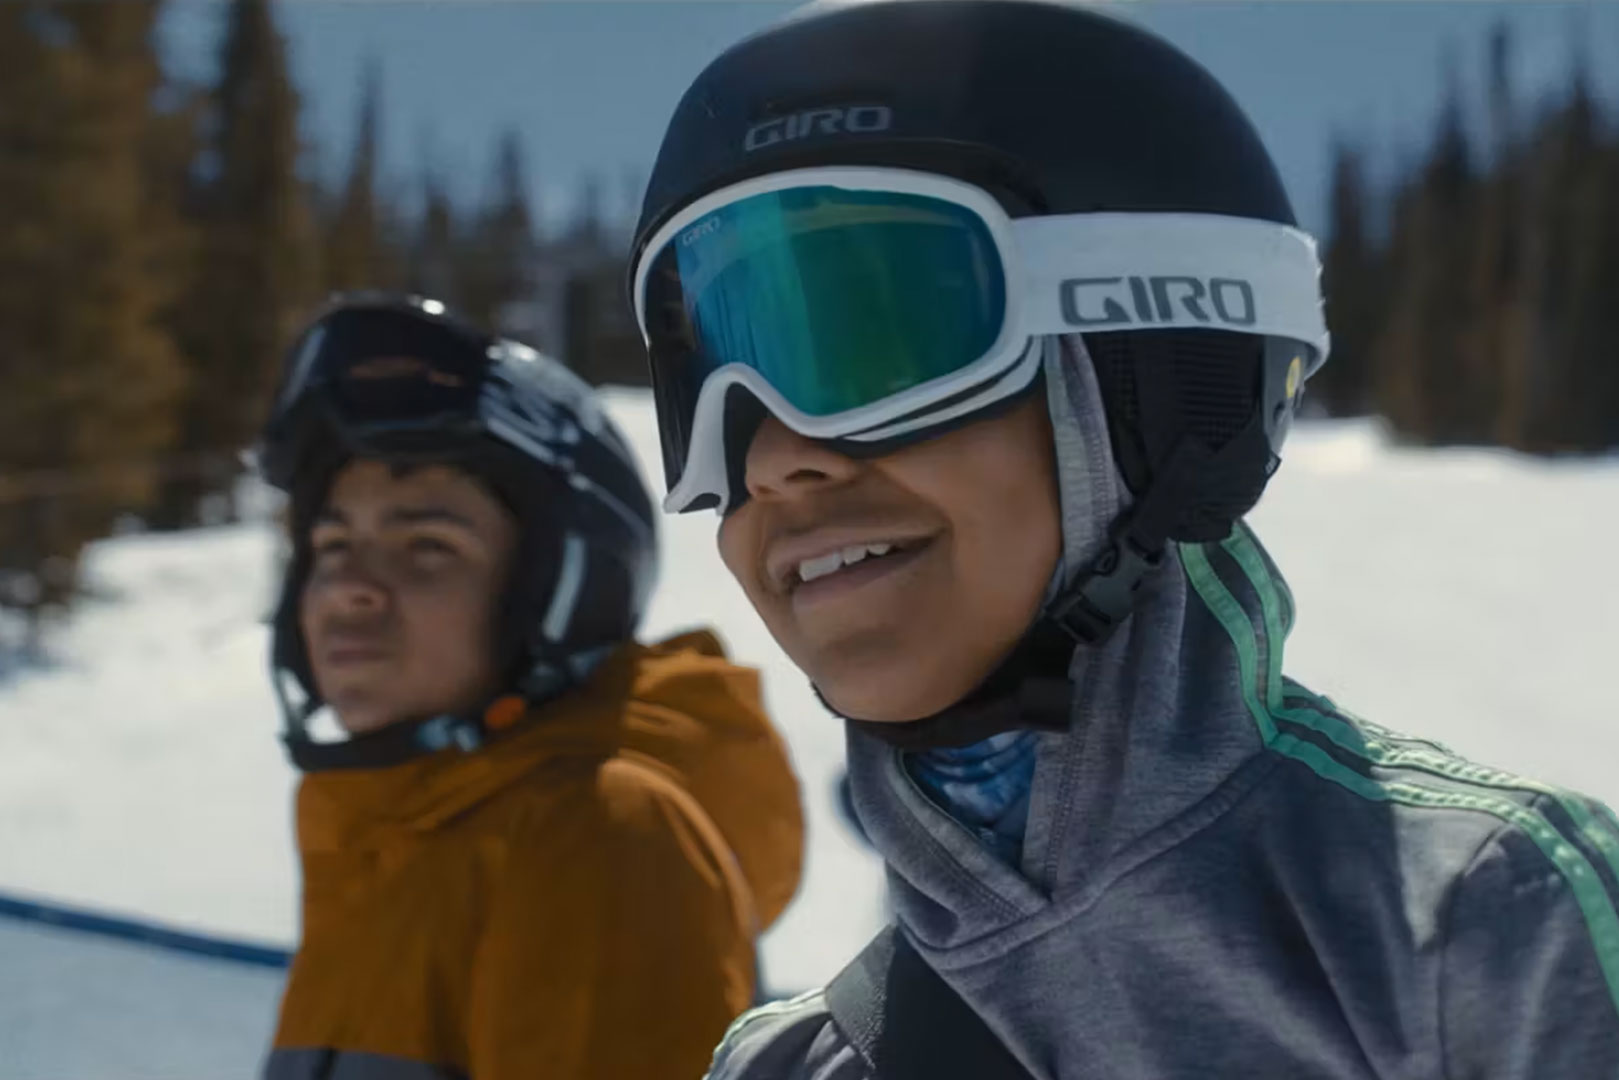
[266,633,803,1080]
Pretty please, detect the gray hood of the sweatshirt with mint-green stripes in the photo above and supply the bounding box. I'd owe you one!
[848,335,1261,968]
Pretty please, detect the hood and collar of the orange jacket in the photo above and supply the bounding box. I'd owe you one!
[298,631,803,925]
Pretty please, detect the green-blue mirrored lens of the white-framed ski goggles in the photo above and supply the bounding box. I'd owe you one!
[646,186,1007,427]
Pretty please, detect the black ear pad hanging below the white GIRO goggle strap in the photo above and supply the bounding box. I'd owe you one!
[1085,330,1297,542]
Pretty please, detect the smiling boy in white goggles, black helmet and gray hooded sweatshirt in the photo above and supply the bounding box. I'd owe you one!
[631,0,1619,1080]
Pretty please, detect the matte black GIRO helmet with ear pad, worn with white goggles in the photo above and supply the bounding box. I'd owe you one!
[631,0,1326,641]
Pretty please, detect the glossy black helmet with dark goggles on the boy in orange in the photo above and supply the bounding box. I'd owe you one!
[257,293,657,771]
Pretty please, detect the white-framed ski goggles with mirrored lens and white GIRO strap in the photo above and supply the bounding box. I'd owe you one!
[631,167,1328,512]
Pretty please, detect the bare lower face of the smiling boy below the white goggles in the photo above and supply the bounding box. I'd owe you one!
[719,393,1062,721]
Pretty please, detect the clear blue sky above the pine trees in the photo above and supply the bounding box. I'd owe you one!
[165,0,1619,238]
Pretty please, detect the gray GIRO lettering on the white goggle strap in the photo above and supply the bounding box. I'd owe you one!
[1059,275,1258,327]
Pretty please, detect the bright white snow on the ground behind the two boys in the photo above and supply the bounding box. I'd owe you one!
[0,390,1619,1077]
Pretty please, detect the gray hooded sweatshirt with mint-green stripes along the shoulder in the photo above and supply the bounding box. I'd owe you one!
[709,338,1619,1080]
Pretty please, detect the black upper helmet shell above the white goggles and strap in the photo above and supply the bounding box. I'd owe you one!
[636,0,1294,243]
